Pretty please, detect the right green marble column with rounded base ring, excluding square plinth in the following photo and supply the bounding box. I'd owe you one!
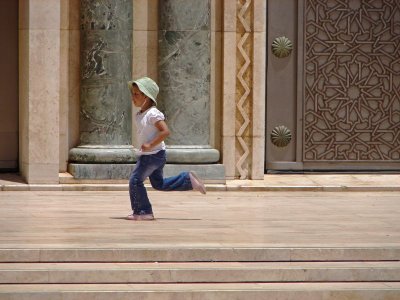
[158,0,219,164]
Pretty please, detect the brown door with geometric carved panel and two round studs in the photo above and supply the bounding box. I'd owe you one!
[266,0,400,170]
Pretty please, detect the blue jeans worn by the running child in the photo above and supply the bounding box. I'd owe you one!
[129,150,193,215]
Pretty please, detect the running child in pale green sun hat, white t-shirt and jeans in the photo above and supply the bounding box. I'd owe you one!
[126,77,206,221]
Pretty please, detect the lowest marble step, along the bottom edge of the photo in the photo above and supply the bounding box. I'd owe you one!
[0,282,400,300]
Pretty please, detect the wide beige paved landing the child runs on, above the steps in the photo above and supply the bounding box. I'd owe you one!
[0,191,400,248]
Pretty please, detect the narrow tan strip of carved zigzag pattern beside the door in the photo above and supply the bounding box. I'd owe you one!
[236,0,253,179]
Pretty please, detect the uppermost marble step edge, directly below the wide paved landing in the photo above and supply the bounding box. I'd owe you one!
[0,245,400,263]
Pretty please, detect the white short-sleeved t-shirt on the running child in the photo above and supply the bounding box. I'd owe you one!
[136,106,165,155]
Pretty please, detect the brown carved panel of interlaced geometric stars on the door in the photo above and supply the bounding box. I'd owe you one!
[303,0,400,162]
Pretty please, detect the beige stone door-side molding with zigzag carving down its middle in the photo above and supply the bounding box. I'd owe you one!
[222,0,266,179]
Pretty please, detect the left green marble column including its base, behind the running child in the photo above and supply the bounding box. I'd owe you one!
[69,0,134,179]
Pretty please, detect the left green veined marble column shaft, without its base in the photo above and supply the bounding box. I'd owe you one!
[80,0,132,145]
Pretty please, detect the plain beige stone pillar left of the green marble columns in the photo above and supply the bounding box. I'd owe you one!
[19,0,61,183]
